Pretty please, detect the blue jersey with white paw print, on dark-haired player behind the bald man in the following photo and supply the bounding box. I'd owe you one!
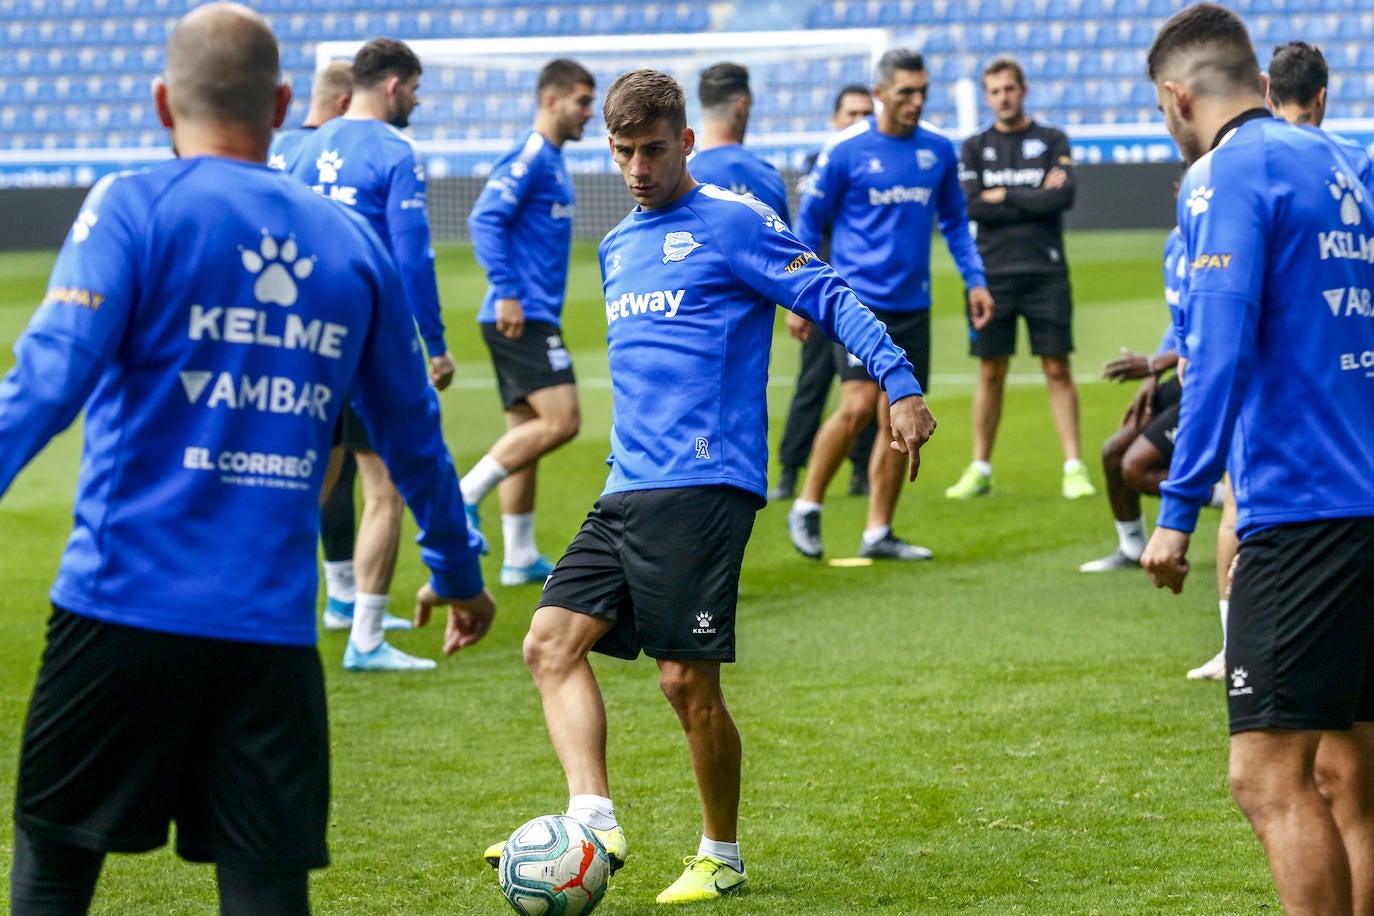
[290,115,447,356]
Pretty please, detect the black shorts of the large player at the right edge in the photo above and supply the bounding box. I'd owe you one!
[1226,516,1374,735]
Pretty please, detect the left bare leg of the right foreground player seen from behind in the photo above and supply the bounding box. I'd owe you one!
[1230,729,1353,913]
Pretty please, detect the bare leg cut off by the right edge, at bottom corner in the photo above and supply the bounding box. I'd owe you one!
[1314,722,1374,916]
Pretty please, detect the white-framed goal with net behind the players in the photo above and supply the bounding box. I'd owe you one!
[316,29,890,239]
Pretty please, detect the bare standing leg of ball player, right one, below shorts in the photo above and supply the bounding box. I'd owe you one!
[658,659,743,843]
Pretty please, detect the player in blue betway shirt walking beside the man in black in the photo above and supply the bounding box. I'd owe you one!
[787,48,992,560]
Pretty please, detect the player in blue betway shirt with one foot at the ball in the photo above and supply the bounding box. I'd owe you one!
[486,70,934,904]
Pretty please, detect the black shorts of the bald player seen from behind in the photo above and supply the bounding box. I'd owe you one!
[15,607,330,873]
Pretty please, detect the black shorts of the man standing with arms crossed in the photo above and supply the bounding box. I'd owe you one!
[969,273,1073,360]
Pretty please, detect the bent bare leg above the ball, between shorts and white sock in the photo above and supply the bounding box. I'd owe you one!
[525,606,611,798]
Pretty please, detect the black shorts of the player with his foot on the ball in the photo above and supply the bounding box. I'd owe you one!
[539,486,760,662]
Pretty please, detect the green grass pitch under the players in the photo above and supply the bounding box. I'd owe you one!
[0,232,1278,915]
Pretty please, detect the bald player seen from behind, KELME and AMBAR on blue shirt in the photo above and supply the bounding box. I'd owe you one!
[0,3,495,916]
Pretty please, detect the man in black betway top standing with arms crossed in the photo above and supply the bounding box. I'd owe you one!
[945,58,1096,500]
